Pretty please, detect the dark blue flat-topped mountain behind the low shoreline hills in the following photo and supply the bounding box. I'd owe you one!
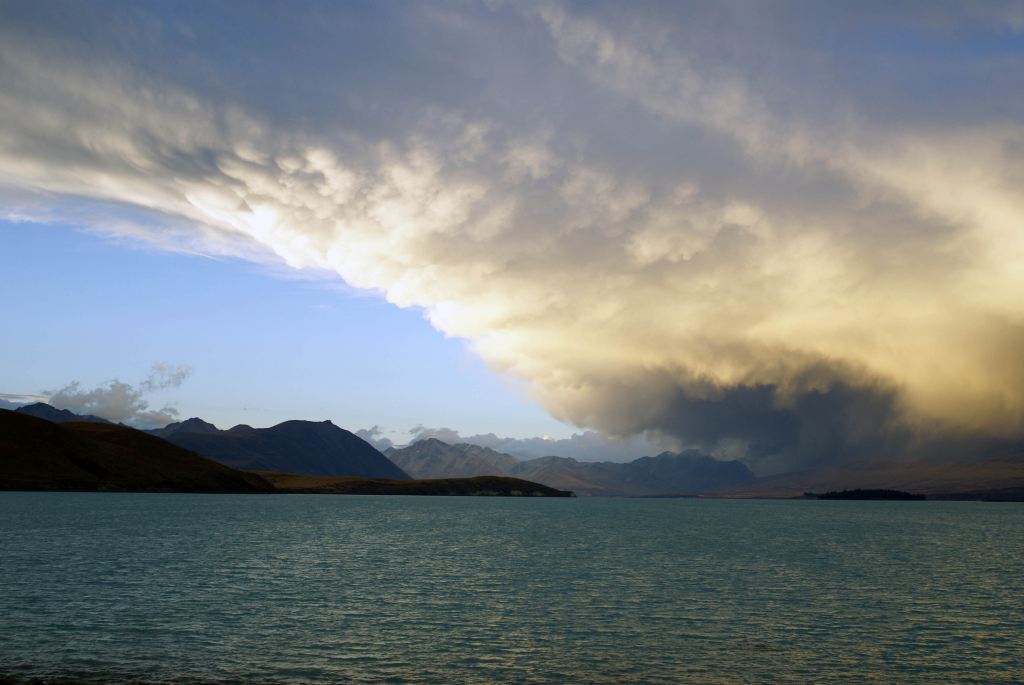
[150,419,409,480]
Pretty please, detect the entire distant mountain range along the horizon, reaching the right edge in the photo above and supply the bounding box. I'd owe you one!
[14,402,1024,500]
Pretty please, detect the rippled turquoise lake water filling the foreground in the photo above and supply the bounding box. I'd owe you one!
[0,493,1024,683]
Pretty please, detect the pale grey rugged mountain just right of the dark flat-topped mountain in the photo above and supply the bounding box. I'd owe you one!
[384,437,519,478]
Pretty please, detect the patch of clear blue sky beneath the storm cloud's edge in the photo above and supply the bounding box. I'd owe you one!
[0,221,569,441]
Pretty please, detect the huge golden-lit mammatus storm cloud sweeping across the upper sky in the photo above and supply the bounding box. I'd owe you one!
[0,3,1024,471]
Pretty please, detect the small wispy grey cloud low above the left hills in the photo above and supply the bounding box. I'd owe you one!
[46,363,191,428]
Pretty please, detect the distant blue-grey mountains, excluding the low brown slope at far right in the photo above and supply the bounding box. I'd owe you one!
[9,402,754,496]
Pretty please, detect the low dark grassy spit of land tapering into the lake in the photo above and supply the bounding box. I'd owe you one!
[259,471,572,497]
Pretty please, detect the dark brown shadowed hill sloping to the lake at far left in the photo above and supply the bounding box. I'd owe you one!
[0,410,272,493]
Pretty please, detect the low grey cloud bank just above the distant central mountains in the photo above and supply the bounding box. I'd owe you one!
[409,426,679,462]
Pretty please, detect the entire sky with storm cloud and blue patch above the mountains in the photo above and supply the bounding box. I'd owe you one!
[0,1,1024,473]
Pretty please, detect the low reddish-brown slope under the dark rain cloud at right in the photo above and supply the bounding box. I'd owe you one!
[722,453,1024,500]
